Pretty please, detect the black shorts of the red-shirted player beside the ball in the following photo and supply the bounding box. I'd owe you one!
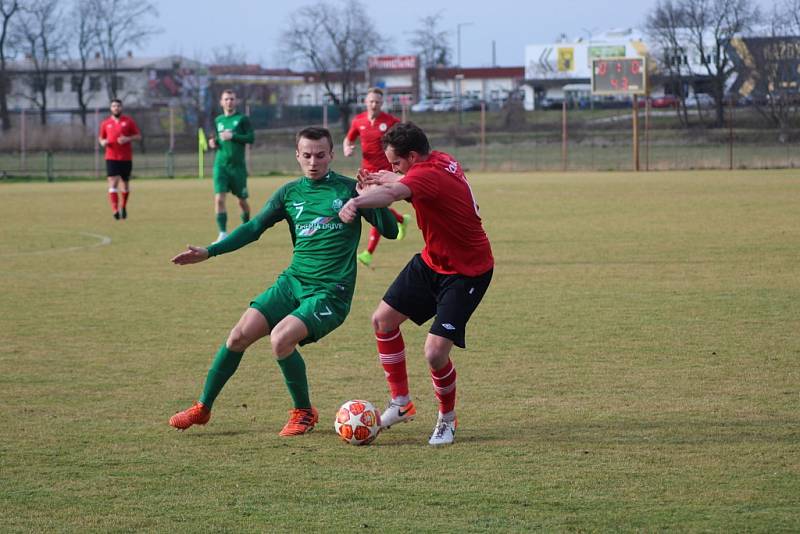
[383,254,494,349]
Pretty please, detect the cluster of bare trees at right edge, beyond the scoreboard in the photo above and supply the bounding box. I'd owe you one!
[644,0,800,129]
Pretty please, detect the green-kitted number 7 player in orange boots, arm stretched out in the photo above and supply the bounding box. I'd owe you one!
[169,127,397,436]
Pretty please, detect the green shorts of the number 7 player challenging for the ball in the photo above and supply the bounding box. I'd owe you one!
[250,273,350,345]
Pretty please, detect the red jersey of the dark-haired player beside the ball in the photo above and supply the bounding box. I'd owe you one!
[400,151,494,276]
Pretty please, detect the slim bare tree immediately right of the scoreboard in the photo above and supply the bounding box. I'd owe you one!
[645,0,692,126]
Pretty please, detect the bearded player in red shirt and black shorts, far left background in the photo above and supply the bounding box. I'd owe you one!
[98,98,142,219]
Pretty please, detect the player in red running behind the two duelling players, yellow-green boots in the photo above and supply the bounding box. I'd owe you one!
[342,87,411,265]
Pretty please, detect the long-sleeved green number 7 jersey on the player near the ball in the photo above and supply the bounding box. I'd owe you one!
[208,171,397,302]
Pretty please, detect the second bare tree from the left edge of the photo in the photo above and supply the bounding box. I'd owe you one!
[12,0,66,125]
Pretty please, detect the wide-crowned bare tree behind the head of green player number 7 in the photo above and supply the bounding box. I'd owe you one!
[280,0,381,130]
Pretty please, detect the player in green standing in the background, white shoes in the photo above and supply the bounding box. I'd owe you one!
[208,89,255,241]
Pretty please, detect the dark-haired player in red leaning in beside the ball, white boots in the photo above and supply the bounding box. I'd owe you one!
[339,123,494,445]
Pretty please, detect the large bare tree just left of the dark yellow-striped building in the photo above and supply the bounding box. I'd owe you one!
[680,0,761,126]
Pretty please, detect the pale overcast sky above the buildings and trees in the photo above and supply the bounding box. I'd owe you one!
[141,0,773,68]
